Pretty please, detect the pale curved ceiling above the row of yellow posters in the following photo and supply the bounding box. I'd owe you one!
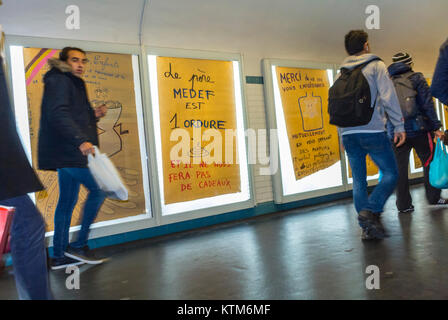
[0,0,448,75]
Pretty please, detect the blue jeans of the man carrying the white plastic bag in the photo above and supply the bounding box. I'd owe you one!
[53,168,106,258]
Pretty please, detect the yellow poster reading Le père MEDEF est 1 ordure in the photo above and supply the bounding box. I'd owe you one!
[157,57,241,204]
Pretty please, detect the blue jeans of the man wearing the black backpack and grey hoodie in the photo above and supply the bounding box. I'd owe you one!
[342,132,398,214]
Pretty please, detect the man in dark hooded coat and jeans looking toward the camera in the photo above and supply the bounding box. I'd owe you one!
[38,47,107,270]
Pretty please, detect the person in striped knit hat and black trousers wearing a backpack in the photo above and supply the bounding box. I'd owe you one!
[387,52,448,213]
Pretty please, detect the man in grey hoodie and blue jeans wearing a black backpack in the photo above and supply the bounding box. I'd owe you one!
[328,30,406,240]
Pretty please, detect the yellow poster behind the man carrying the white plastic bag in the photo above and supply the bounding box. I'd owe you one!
[23,48,146,231]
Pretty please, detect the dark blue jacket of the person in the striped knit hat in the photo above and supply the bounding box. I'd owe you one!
[387,62,442,138]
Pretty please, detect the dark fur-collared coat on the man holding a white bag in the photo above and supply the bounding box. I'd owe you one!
[38,59,98,170]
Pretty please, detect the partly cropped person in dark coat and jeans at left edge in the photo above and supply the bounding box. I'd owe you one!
[0,56,53,300]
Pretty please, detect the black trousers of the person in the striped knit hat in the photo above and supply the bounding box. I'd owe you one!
[394,133,441,210]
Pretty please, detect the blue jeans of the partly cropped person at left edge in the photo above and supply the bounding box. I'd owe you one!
[0,195,53,300]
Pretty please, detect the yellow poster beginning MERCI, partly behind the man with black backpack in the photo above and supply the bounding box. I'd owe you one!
[276,67,340,180]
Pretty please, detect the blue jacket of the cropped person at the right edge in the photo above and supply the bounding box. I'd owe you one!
[431,39,448,105]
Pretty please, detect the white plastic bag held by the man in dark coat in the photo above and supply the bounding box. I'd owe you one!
[87,146,128,200]
